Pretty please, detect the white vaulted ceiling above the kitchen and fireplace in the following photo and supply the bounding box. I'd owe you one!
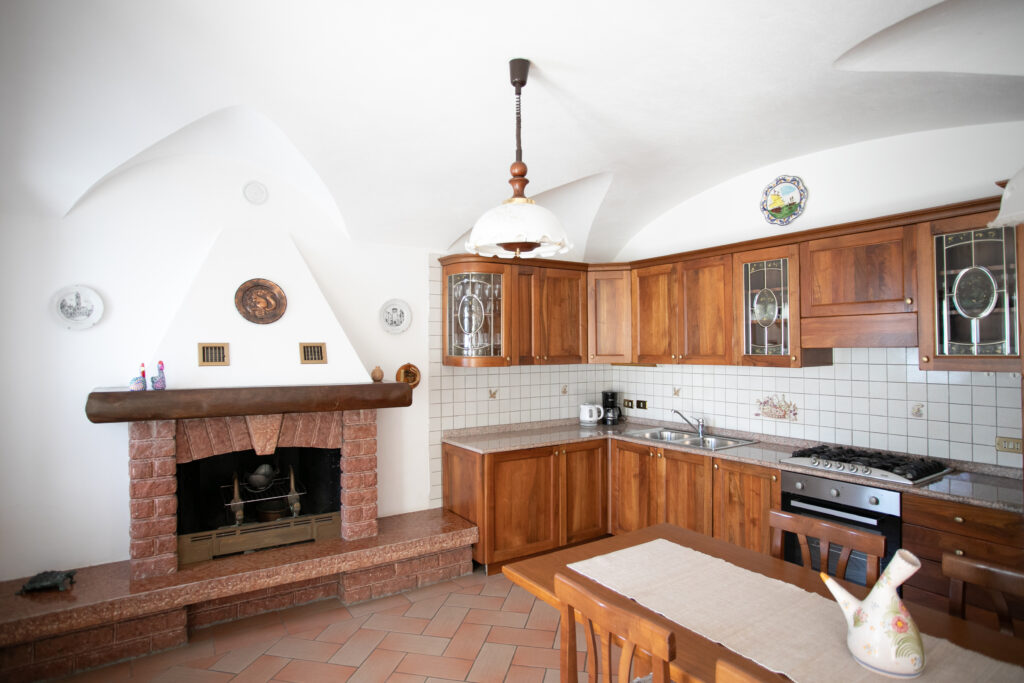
[0,0,1024,260]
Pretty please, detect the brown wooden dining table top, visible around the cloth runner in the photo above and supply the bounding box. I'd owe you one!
[502,524,1024,683]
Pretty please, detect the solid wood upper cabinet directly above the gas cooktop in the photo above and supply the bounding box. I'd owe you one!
[800,226,918,348]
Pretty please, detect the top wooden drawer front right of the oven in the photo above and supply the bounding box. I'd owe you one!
[903,496,1024,548]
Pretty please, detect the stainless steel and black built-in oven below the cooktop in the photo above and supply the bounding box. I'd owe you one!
[782,470,900,586]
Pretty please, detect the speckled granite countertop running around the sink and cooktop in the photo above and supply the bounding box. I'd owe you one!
[441,420,1024,513]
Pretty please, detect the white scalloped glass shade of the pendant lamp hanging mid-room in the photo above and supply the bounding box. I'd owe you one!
[466,200,572,258]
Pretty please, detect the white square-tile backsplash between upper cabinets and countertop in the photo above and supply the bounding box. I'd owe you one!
[429,257,1022,505]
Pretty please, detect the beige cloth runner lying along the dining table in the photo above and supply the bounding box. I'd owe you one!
[568,539,1024,683]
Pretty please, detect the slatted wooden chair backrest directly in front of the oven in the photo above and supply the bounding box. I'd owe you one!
[768,510,886,588]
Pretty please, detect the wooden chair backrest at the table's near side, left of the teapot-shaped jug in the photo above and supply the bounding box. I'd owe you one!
[555,573,676,683]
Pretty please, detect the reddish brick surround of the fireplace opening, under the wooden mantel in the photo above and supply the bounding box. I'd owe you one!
[128,409,377,580]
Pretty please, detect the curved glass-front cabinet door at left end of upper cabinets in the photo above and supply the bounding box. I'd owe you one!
[441,262,511,367]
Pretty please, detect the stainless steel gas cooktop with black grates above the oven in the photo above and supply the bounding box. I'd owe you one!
[780,444,952,485]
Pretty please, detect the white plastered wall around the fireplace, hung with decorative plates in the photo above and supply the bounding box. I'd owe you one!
[0,150,429,580]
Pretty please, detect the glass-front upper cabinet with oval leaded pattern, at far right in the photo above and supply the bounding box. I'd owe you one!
[918,211,1022,372]
